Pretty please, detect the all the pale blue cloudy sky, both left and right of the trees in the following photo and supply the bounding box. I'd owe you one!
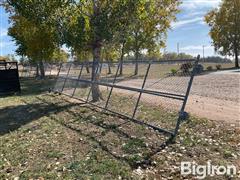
[0,0,221,56]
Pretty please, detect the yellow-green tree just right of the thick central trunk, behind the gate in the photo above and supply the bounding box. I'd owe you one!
[128,0,179,75]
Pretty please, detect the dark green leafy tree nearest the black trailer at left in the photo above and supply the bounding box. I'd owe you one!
[1,0,65,78]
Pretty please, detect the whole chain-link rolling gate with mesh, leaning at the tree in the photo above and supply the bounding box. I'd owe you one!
[52,56,200,138]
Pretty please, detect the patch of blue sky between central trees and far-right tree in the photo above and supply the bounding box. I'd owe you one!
[166,0,221,56]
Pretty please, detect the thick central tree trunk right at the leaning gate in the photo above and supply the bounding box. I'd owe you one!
[92,45,102,102]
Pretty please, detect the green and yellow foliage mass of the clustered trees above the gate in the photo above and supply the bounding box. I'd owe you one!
[4,0,179,91]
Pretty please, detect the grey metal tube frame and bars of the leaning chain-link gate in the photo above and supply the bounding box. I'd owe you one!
[51,56,200,139]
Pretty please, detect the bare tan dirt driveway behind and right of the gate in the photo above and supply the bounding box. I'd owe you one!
[115,70,240,127]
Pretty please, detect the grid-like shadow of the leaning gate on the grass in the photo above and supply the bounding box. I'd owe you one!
[35,95,173,169]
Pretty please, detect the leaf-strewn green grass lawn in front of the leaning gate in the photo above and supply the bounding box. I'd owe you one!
[0,78,240,179]
